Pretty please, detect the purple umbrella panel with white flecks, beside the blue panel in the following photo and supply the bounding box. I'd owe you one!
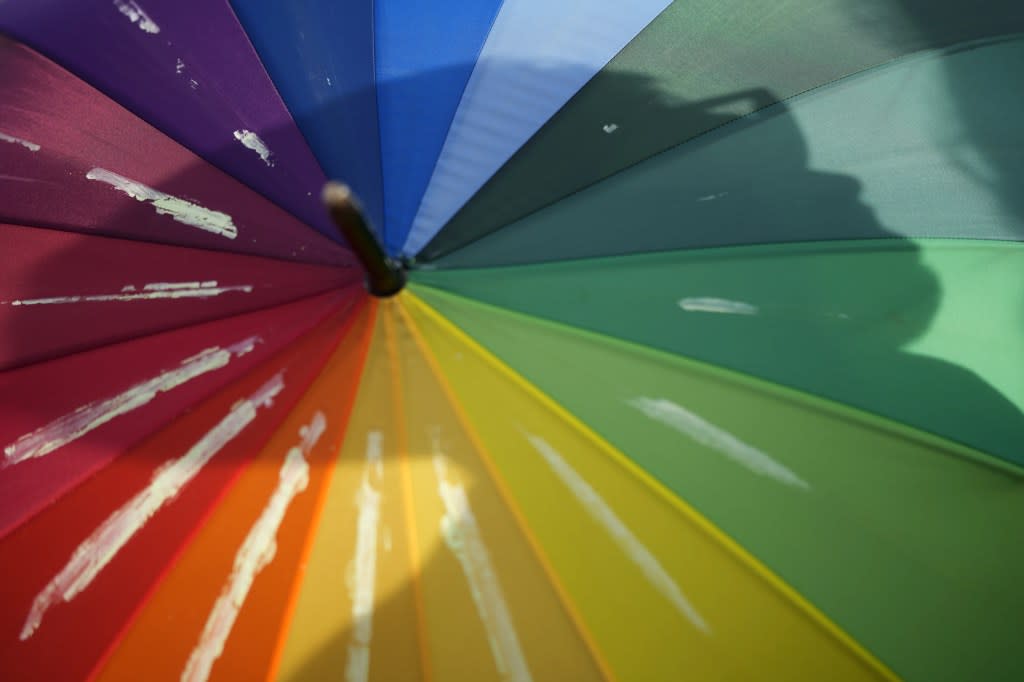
[0,0,344,238]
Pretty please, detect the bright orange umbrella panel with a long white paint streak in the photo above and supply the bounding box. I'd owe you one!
[95,306,369,680]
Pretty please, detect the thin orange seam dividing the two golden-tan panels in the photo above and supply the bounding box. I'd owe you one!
[381,300,433,682]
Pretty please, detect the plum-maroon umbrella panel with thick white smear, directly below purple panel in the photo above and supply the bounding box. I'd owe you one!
[0,39,353,265]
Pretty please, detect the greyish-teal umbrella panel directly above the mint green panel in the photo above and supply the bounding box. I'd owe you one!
[428,33,1024,267]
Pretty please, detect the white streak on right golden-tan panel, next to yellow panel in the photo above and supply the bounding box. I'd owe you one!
[433,434,532,682]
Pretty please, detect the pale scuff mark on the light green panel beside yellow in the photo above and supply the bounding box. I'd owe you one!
[627,396,811,491]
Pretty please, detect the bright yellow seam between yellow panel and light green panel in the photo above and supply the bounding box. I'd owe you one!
[402,292,899,682]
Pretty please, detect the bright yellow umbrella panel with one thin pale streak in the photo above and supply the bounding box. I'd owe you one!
[403,294,891,681]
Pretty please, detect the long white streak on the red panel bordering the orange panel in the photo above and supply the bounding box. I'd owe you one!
[20,374,285,641]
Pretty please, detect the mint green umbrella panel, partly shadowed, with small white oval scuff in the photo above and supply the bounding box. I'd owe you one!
[414,240,1024,466]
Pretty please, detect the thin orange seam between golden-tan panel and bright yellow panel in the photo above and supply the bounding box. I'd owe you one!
[397,294,616,682]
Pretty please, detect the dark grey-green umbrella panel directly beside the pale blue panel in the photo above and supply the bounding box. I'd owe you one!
[420,0,1024,260]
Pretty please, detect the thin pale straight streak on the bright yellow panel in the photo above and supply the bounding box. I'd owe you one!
[524,432,711,635]
